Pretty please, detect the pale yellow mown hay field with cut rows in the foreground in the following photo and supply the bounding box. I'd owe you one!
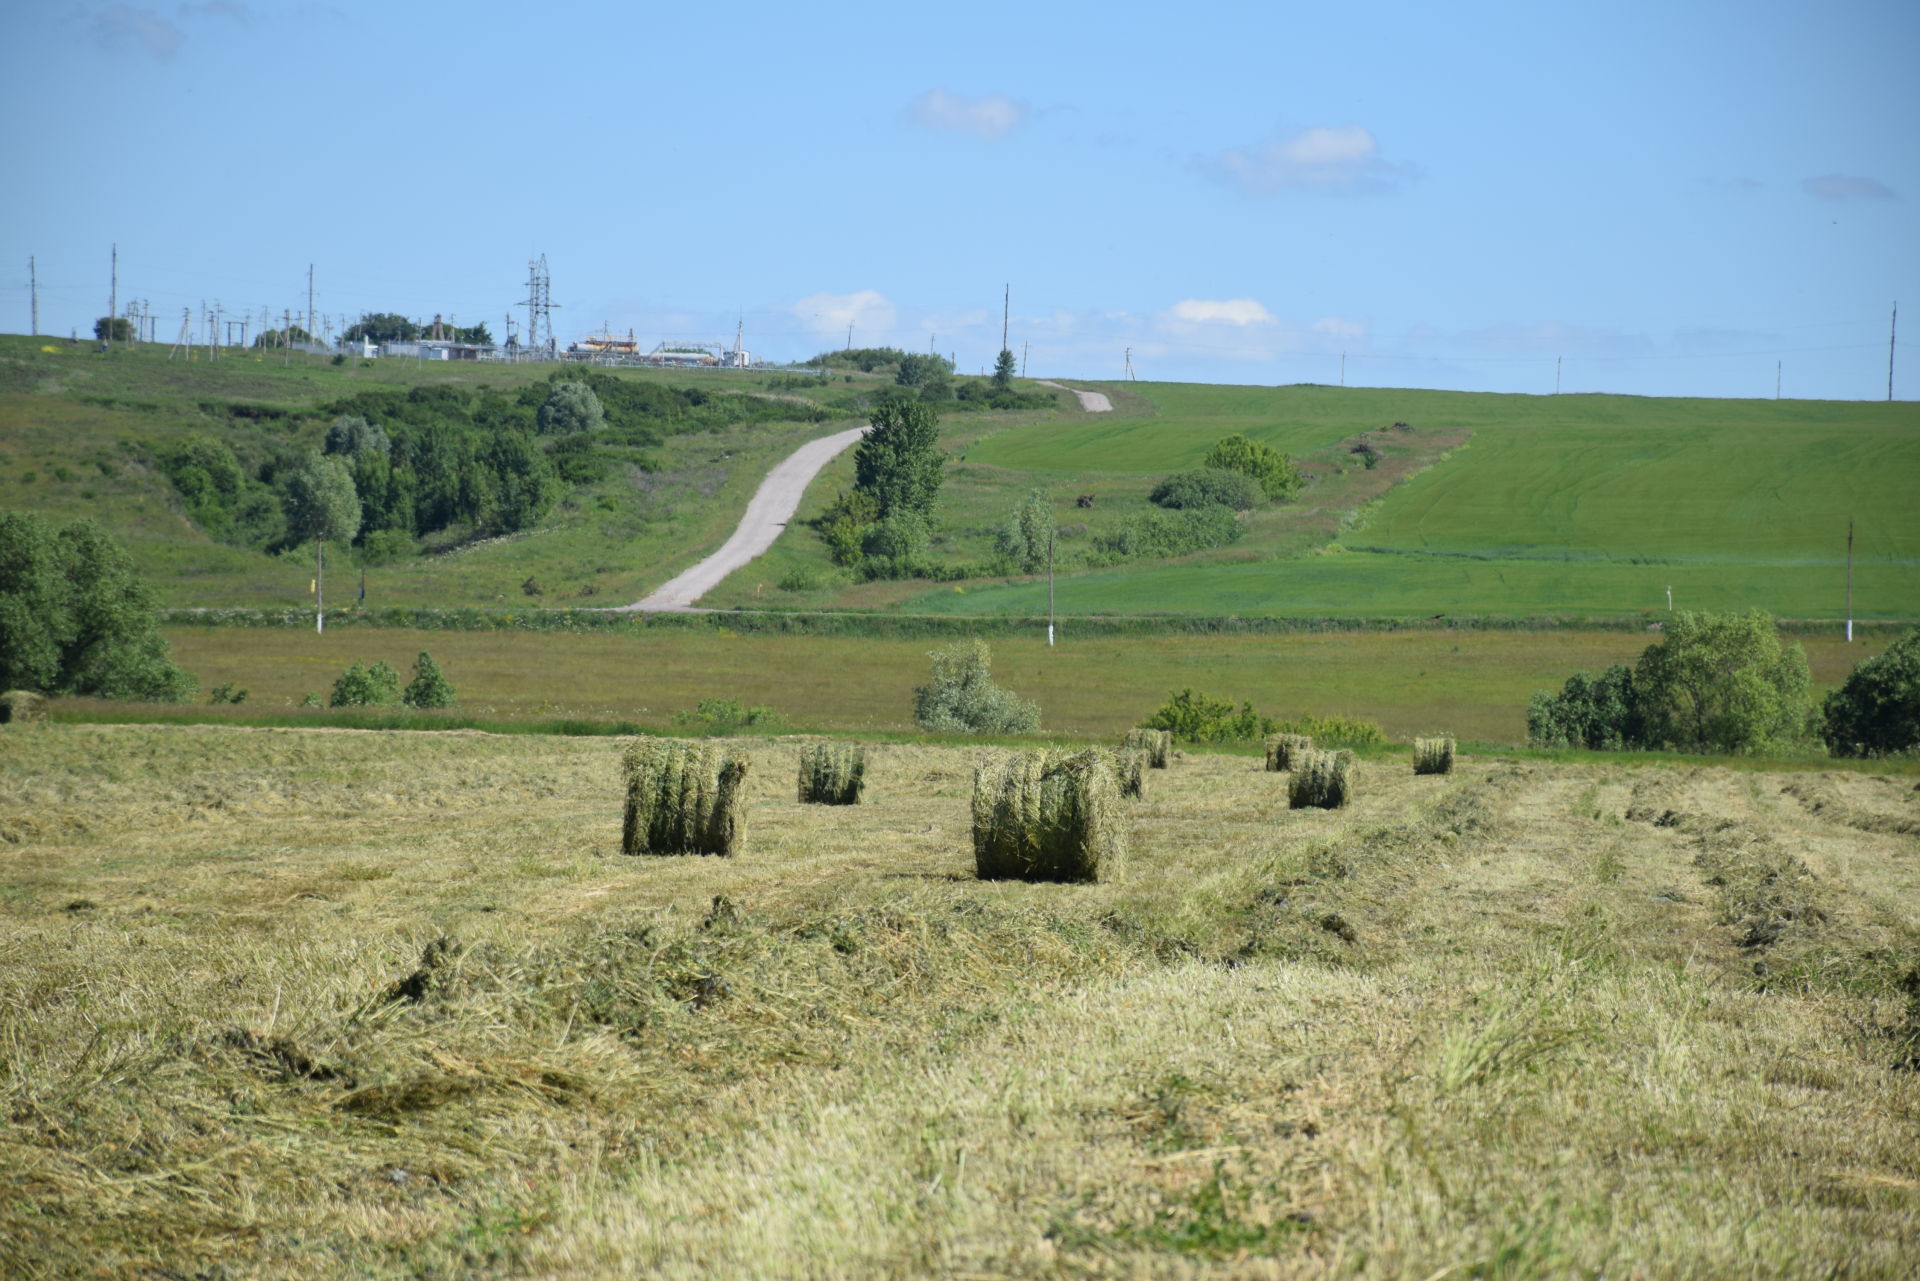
[0,724,1920,1279]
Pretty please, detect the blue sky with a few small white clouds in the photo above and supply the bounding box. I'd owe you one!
[0,0,1920,399]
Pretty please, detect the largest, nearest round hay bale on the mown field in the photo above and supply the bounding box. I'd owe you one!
[973,749,1127,882]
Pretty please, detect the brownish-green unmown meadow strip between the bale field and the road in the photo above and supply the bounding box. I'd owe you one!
[153,624,1891,743]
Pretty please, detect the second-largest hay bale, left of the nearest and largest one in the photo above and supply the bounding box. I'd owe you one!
[620,739,747,855]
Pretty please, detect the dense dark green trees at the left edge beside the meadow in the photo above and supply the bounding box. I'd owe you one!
[0,513,198,703]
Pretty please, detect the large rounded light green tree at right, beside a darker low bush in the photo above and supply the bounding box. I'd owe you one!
[1634,609,1812,753]
